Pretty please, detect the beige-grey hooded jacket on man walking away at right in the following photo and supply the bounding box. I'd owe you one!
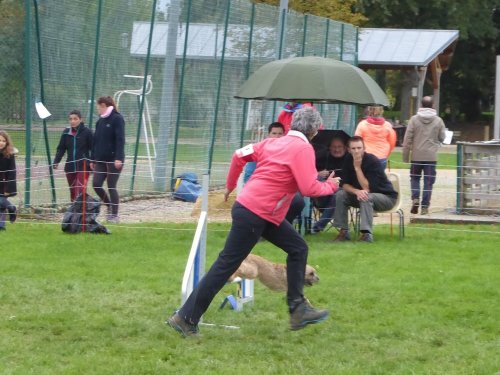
[403,108,445,163]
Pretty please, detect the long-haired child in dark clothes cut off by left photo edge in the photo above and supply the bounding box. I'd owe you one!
[0,130,17,231]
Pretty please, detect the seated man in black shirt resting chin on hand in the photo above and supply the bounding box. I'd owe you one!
[334,136,398,242]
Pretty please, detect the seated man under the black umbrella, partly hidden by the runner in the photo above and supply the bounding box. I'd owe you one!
[312,136,347,234]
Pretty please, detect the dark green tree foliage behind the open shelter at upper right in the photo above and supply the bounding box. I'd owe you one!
[356,0,499,120]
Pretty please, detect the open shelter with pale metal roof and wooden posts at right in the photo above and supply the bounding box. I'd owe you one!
[358,28,459,110]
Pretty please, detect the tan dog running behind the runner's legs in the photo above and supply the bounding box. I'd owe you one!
[229,254,319,292]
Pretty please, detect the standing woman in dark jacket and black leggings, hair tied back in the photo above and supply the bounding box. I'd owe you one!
[91,96,125,223]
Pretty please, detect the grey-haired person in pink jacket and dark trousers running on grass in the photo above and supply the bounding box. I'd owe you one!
[167,107,339,336]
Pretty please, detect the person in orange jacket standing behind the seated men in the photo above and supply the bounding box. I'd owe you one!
[354,106,397,169]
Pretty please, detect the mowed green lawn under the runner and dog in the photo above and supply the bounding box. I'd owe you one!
[0,223,500,374]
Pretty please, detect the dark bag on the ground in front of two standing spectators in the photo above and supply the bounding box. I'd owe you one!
[61,194,110,234]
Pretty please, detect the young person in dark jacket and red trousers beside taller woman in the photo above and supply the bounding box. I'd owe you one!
[54,110,92,202]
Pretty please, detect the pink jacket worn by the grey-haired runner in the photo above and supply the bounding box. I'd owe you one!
[226,130,338,225]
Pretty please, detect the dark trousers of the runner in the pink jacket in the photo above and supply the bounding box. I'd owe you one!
[178,202,308,324]
